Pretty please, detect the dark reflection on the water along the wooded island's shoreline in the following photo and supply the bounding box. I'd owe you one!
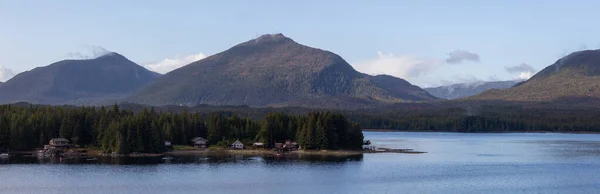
[0,154,363,165]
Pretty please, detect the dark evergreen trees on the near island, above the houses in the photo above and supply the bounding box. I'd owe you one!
[0,105,363,154]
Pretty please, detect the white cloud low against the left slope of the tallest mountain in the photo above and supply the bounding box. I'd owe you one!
[144,53,206,74]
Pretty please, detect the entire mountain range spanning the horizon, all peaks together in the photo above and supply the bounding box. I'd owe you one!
[5,34,600,109]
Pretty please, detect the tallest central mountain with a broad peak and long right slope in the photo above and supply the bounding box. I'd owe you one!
[127,34,436,107]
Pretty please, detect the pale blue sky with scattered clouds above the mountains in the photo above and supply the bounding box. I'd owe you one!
[0,0,600,87]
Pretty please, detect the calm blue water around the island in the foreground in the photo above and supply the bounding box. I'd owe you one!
[0,132,600,193]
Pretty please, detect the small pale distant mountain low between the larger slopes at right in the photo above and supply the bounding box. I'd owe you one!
[424,80,520,99]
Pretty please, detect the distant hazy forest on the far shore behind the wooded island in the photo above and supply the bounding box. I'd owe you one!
[118,101,600,133]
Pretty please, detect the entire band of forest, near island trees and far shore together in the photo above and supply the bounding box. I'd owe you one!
[0,100,600,153]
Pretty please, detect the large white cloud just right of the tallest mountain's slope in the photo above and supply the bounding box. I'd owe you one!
[353,51,444,81]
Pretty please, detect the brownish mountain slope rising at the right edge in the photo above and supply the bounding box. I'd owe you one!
[473,50,600,102]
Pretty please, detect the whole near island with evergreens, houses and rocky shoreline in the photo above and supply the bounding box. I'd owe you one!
[0,105,410,158]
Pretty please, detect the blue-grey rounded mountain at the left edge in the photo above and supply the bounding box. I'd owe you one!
[0,53,159,104]
